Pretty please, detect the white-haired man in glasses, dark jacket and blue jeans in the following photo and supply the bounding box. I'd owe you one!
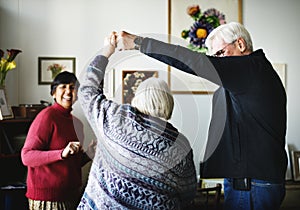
[118,22,287,210]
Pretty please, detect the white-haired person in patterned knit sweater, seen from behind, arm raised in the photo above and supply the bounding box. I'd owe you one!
[78,33,197,210]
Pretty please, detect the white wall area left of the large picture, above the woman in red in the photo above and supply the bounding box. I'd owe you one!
[0,0,167,149]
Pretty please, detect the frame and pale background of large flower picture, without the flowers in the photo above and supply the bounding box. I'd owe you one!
[168,0,242,94]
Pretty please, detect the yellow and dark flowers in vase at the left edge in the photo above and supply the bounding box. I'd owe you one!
[0,49,22,86]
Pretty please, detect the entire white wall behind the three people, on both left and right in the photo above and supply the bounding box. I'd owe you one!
[0,0,300,178]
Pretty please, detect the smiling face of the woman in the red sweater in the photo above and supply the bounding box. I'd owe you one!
[53,83,77,109]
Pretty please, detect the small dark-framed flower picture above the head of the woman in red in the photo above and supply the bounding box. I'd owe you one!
[38,57,76,85]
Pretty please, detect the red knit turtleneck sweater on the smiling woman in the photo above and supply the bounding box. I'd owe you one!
[21,103,83,201]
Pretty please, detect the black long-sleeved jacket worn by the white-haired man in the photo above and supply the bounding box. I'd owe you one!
[141,38,287,182]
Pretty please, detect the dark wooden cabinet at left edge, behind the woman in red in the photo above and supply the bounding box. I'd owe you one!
[0,107,45,210]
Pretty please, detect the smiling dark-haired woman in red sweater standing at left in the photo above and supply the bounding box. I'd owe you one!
[21,72,94,210]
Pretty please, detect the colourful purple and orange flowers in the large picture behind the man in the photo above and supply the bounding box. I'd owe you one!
[181,5,226,53]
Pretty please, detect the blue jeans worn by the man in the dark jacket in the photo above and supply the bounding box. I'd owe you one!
[224,179,285,210]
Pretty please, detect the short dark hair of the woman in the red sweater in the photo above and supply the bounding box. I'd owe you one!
[50,71,79,95]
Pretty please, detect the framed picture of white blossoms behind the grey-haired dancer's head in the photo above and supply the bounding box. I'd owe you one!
[122,70,158,104]
